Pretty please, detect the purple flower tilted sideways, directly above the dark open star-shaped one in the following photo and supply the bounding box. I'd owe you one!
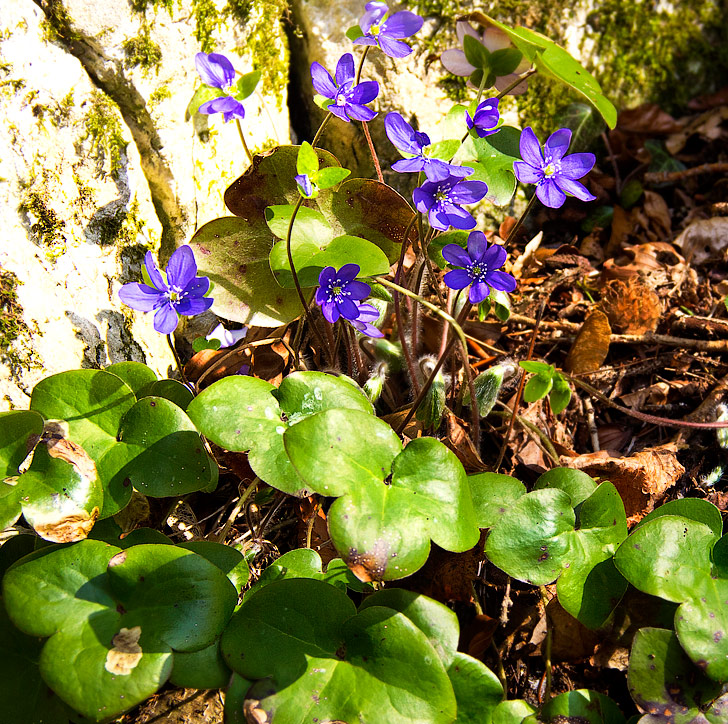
[412,176,488,231]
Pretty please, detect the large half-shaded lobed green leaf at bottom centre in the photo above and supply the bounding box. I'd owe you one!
[222,579,455,724]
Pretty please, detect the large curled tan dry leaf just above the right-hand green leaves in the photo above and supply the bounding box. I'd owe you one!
[569,443,685,525]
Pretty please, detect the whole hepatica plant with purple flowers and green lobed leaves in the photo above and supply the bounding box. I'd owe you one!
[5,2,692,724]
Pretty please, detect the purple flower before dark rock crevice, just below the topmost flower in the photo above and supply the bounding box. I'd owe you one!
[311,53,379,123]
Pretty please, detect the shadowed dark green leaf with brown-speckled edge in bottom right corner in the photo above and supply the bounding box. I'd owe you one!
[627,628,720,724]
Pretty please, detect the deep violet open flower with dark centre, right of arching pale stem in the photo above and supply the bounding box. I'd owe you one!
[442,231,516,304]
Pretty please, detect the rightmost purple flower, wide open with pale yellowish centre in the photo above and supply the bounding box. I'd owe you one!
[513,126,596,209]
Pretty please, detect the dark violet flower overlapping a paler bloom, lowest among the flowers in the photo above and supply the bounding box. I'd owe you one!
[316,264,384,337]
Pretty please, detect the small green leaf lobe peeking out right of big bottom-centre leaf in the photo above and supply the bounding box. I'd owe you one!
[447,652,503,724]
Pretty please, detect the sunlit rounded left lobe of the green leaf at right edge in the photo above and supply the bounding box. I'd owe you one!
[614,515,717,603]
